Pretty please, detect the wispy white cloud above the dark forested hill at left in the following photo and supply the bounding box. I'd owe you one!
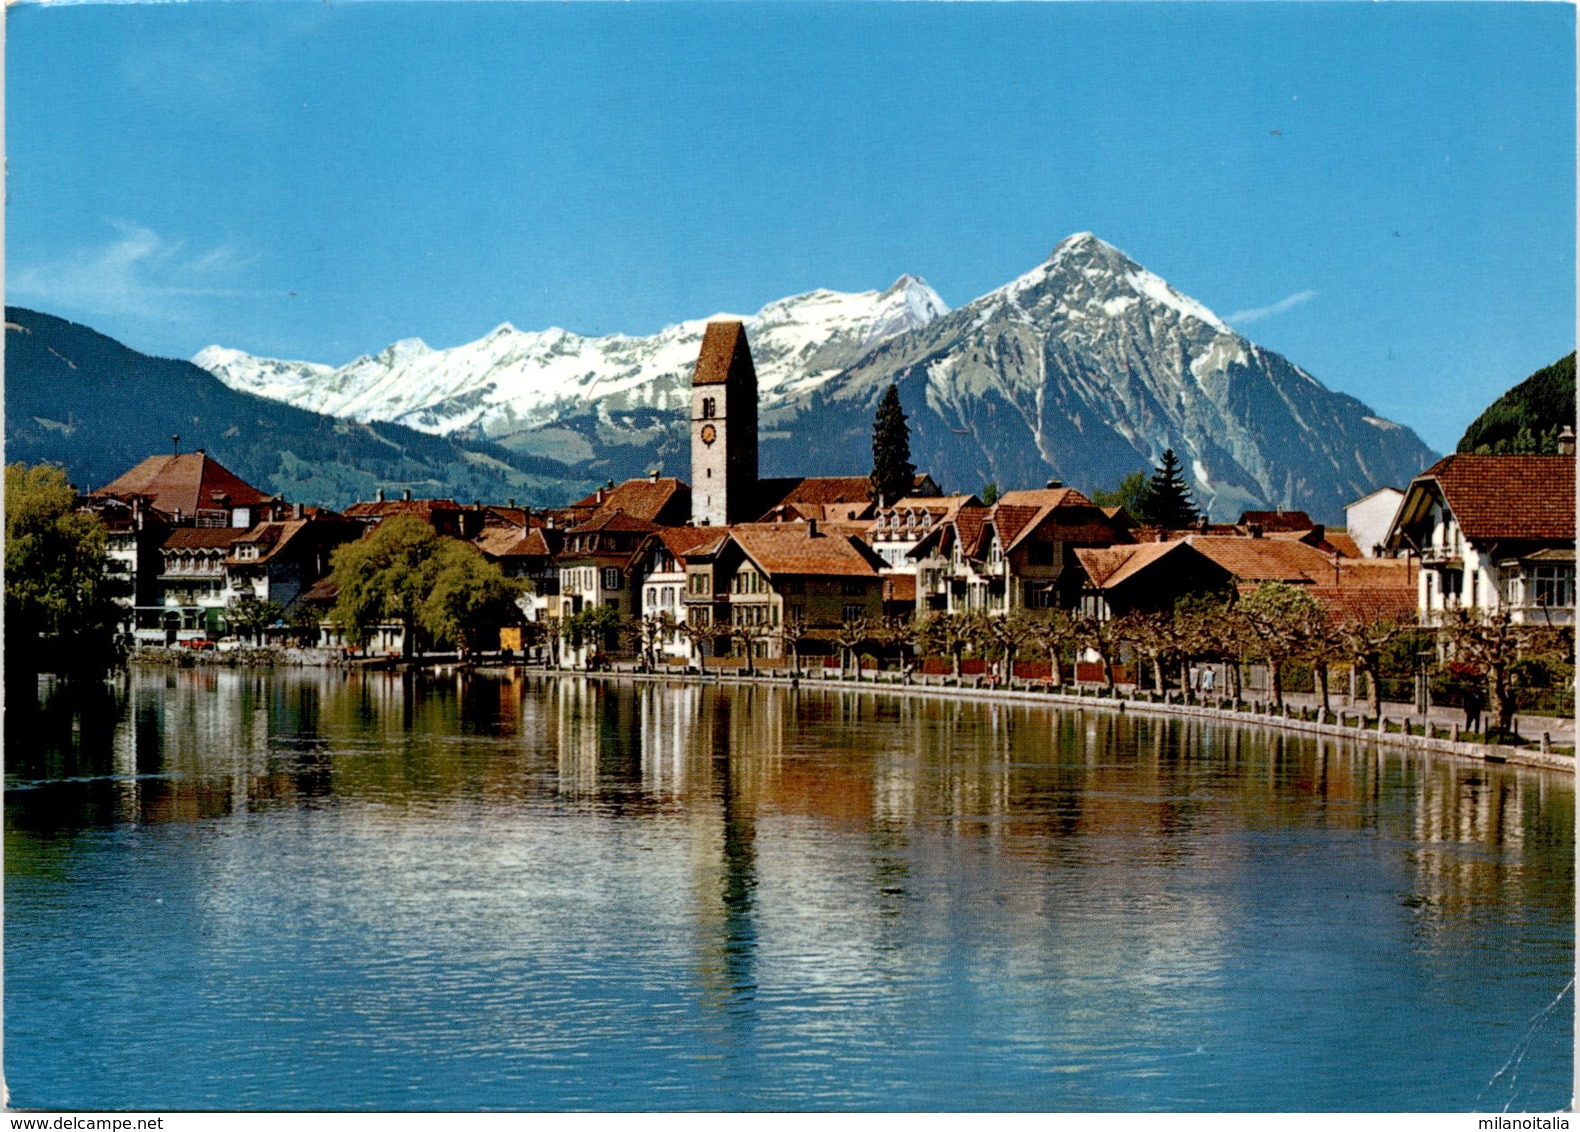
[6,220,262,321]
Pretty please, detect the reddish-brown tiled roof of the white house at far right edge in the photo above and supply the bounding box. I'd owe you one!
[1411,452,1575,542]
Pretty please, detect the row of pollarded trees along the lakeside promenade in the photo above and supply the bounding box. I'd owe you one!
[539,582,1574,734]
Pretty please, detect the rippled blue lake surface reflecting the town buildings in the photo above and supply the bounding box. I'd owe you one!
[5,670,1575,1110]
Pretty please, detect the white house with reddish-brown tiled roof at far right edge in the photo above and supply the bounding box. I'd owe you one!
[1387,452,1575,624]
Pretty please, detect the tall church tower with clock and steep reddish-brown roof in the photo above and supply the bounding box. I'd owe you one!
[692,323,757,526]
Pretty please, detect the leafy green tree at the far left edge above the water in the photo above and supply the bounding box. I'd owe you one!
[5,463,125,679]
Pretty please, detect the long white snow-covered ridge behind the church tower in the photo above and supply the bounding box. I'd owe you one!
[193,275,948,460]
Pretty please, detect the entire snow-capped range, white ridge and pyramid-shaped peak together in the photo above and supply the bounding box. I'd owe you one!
[193,232,1435,520]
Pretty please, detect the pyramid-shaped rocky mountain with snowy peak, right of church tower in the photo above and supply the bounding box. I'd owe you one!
[765,232,1436,522]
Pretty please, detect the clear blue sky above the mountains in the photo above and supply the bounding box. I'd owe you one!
[6,3,1575,449]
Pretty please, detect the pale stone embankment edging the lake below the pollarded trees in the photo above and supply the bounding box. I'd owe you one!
[529,669,1575,775]
